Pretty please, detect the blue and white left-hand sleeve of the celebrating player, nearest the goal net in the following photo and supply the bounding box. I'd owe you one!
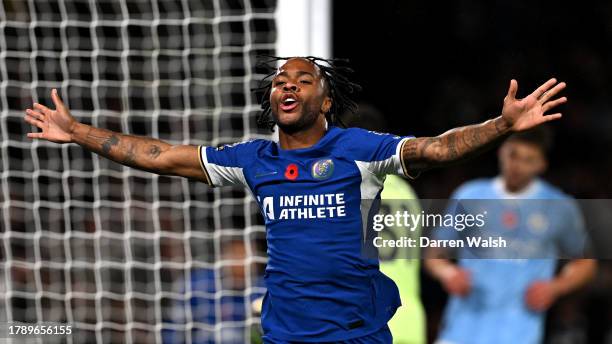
[198,141,252,186]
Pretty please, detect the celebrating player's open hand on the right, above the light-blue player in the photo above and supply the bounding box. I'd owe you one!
[502,78,567,131]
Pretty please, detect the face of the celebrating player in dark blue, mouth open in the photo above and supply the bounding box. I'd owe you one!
[270,58,331,133]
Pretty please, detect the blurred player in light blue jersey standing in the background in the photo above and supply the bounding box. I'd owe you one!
[425,127,596,344]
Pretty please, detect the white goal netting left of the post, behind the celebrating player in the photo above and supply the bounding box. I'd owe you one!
[0,0,276,343]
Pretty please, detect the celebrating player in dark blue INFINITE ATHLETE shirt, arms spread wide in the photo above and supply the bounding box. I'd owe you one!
[25,57,566,343]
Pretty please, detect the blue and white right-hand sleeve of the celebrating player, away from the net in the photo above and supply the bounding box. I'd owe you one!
[357,130,414,178]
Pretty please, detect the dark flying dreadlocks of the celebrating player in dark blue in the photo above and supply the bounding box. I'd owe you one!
[252,55,361,131]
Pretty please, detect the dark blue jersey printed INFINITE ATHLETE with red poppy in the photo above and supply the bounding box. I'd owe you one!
[200,126,409,342]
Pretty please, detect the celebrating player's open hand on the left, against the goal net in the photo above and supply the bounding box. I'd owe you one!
[24,89,78,143]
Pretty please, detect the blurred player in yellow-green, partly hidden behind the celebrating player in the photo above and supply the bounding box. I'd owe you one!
[343,103,427,344]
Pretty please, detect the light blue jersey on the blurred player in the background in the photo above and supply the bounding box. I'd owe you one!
[436,178,585,344]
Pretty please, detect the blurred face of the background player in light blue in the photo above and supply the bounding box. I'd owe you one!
[499,141,546,191]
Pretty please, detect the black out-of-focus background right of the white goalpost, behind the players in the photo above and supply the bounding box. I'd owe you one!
[333,0,612,343]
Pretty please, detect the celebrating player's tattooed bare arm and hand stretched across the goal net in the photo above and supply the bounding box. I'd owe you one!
[25,89,206,182]
